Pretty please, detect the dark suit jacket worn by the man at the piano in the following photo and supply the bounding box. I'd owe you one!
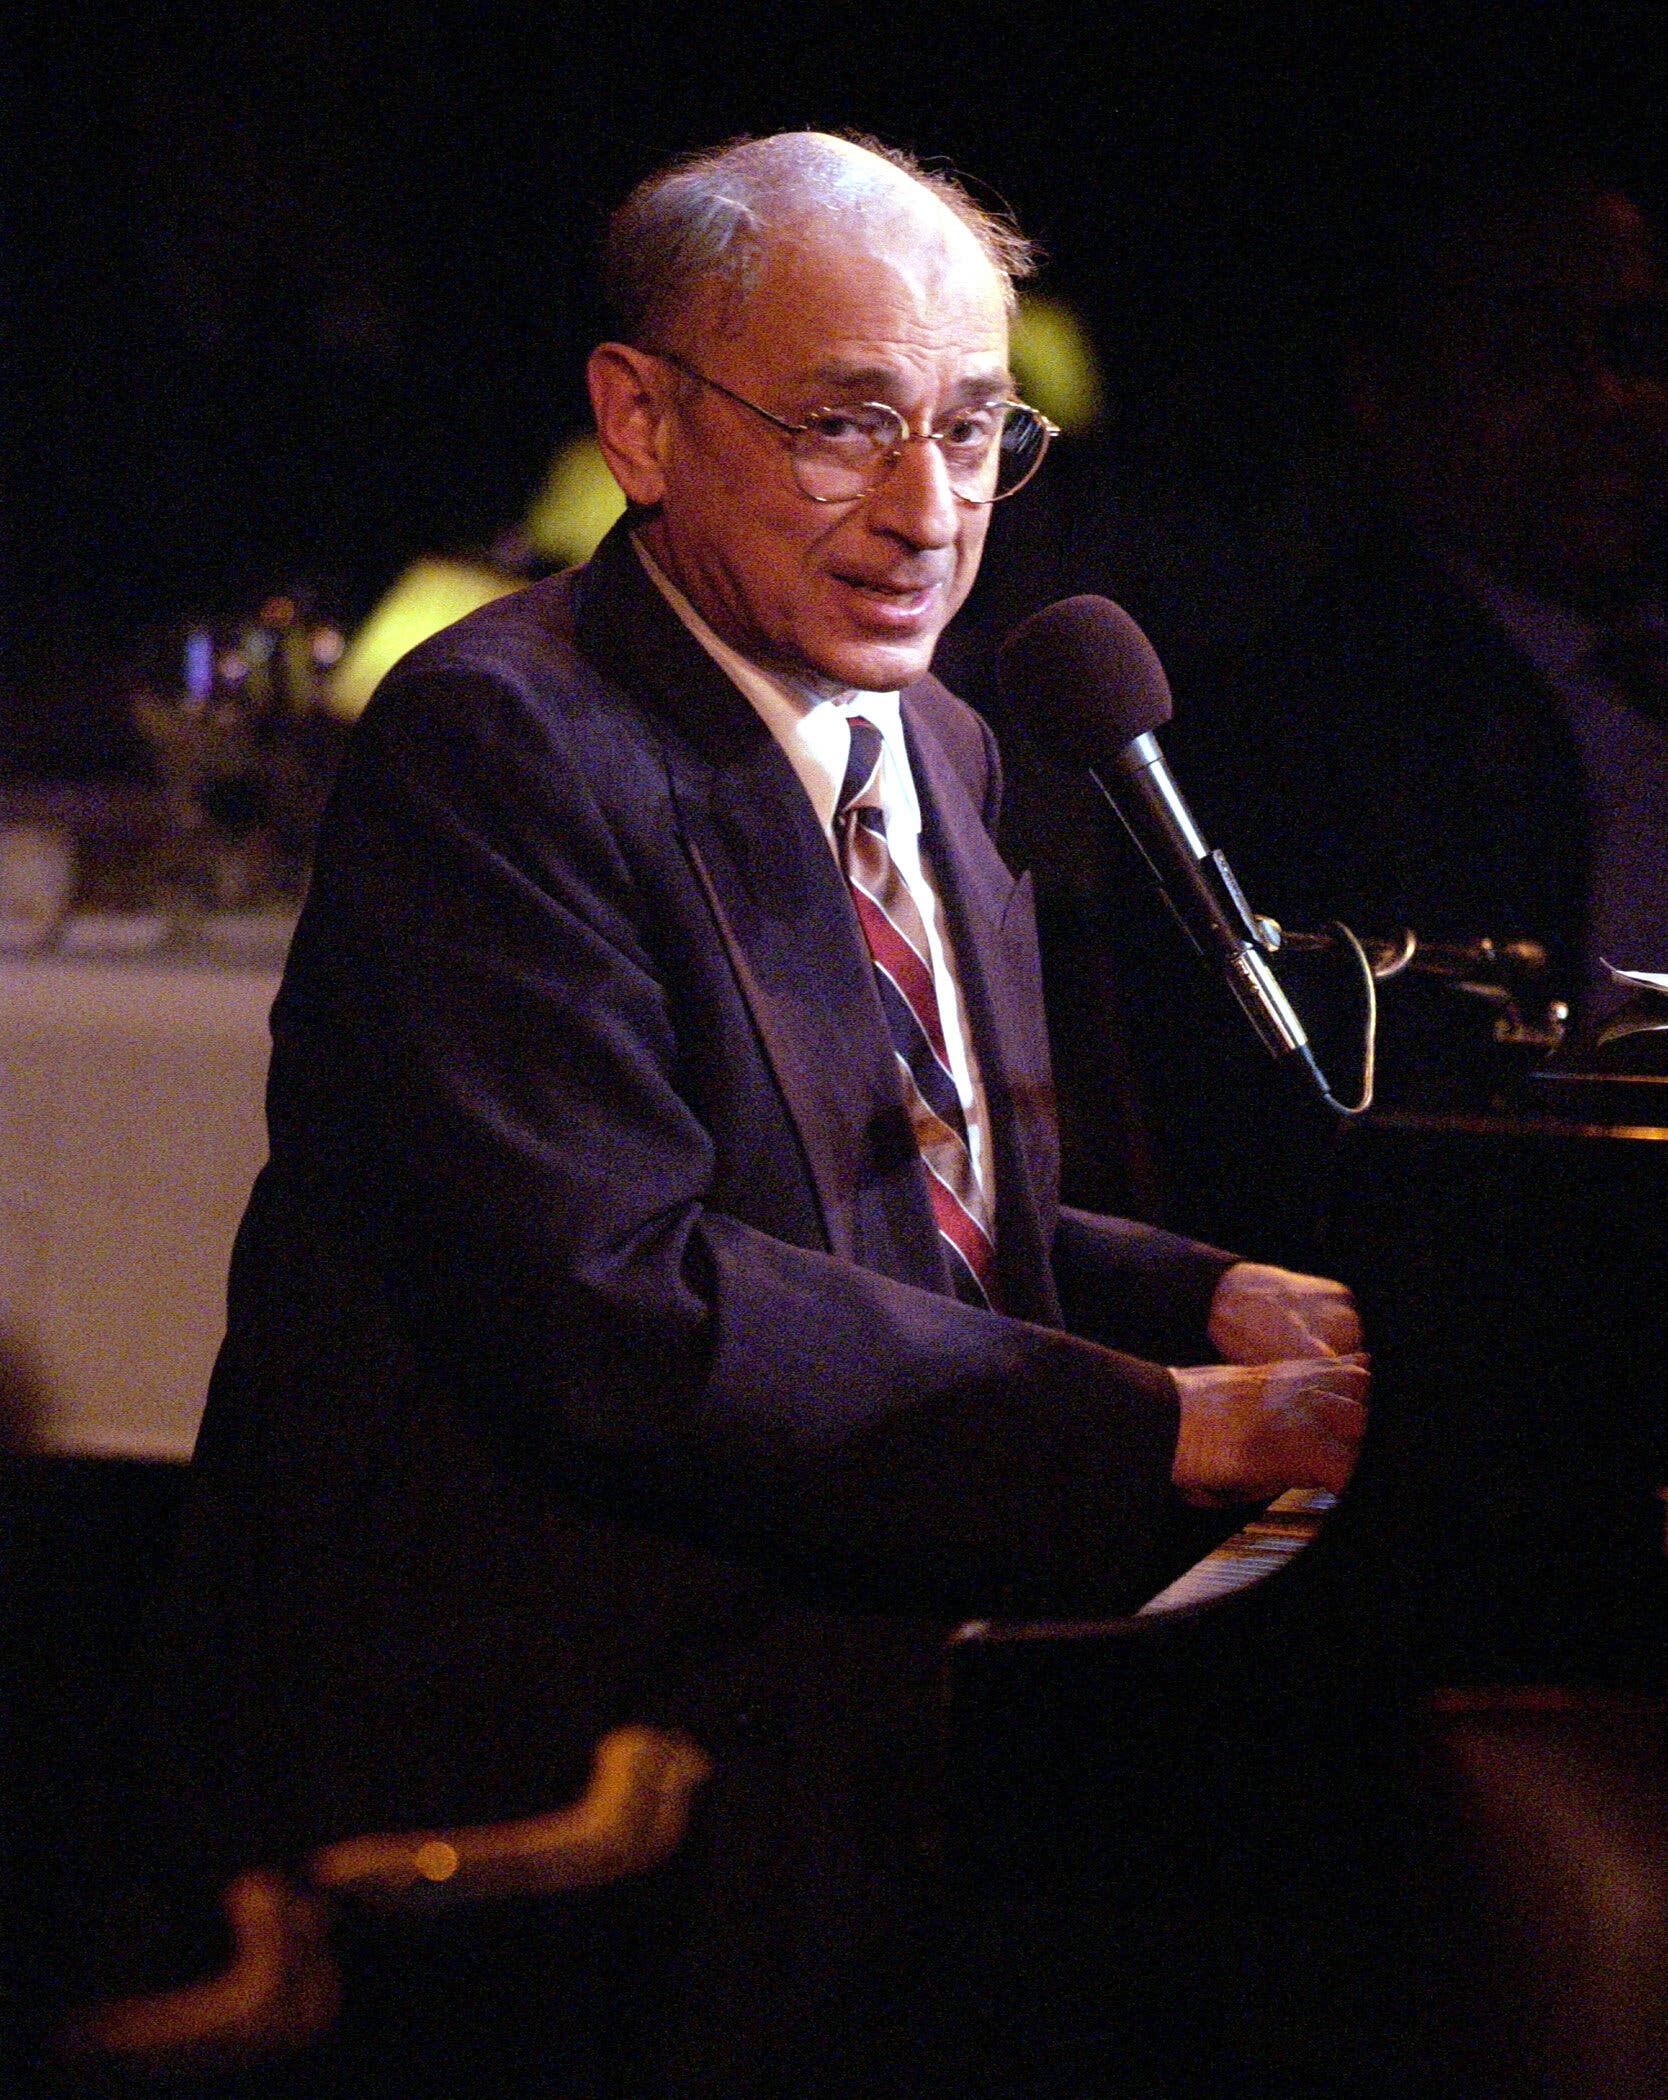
[117,516,1227,2092]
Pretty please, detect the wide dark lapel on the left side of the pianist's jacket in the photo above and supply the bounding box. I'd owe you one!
[576,533,947,1289]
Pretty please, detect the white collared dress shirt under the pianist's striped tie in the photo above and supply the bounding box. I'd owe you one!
[632,540,996,1216]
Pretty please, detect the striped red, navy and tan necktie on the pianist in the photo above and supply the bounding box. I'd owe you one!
[834,714,996,1304]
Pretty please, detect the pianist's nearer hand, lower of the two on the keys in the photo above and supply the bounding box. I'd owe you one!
[1170,1357,1368,1508]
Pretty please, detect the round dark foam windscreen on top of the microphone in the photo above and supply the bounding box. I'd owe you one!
[998,596,1170,764]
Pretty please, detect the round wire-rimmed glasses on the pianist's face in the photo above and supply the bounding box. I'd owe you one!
[655,351,1059,504]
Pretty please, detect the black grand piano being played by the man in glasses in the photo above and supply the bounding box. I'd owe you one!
[945,1073,1668,2100]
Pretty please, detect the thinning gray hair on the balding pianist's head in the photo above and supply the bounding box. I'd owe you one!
[605,132,1038,349]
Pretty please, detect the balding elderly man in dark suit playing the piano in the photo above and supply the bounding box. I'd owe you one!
[117,134,1365,2100]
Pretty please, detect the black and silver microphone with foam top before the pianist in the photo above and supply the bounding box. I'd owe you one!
[1000,596,1338,1109]
